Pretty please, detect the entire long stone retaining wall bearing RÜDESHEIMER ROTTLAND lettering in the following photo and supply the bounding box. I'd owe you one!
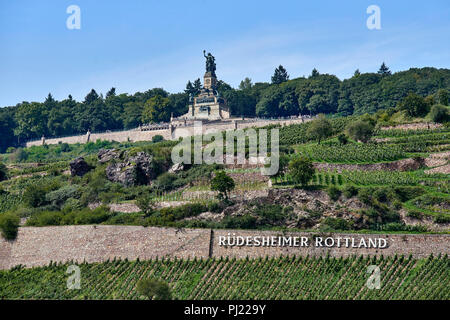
[0,225,450,269]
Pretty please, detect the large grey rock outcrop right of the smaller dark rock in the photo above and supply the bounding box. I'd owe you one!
[106,152,156,187]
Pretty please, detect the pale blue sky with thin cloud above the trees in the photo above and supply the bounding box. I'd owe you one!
[0,0,450,106]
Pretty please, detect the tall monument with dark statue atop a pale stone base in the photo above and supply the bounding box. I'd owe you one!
[180,50,230,120]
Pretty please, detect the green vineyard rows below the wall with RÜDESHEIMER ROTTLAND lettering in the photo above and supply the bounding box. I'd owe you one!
[0,256,450,300]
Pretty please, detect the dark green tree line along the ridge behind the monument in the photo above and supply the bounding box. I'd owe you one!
[0,63,450,152]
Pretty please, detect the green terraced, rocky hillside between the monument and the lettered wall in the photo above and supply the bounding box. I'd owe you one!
[0,112,450,239]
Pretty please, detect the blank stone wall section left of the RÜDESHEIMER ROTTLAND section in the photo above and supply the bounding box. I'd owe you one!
[0,225,210,269]
